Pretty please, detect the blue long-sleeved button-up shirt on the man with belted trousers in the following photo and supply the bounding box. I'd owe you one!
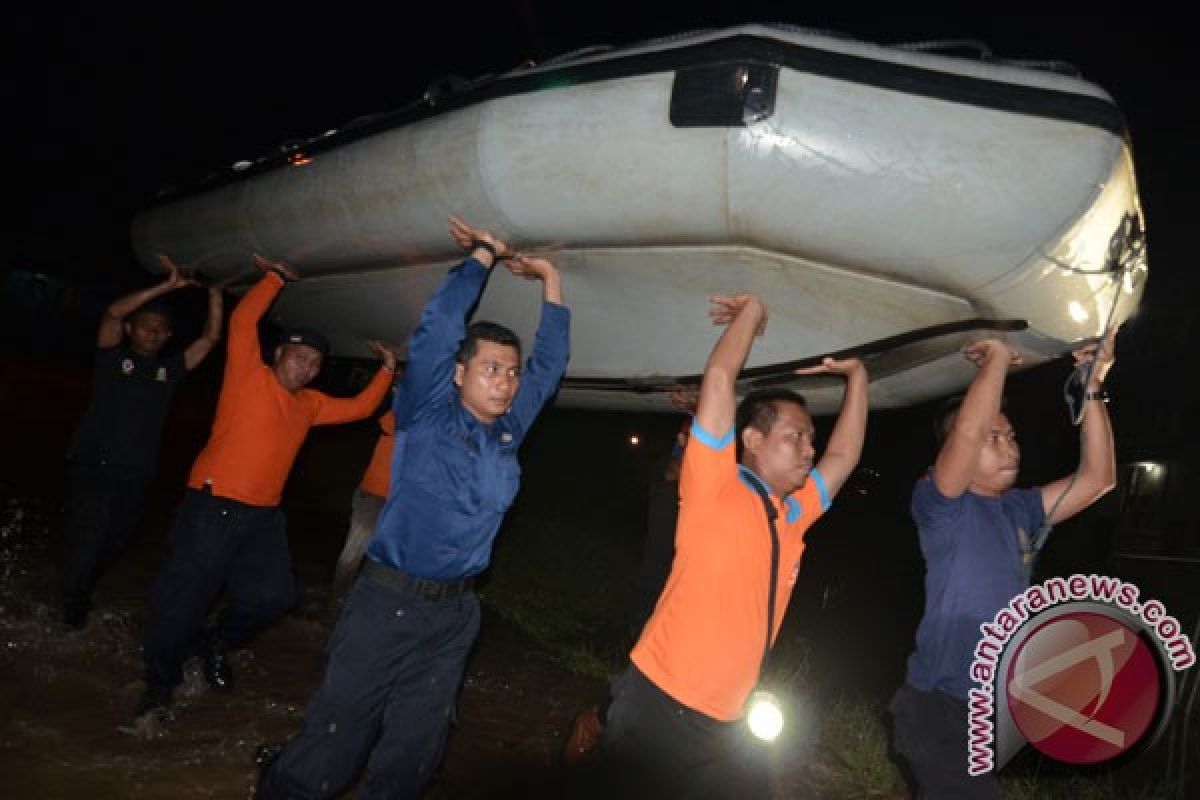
[367,259,570,581]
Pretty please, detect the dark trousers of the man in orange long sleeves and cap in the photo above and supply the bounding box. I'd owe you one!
[145,489,295,693]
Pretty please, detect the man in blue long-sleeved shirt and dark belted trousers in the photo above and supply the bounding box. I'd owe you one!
[259,217,570,800]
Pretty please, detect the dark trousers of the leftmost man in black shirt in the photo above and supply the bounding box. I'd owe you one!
[62,462,154,612]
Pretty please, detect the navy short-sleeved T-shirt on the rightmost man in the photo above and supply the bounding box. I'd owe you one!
[907,477,1045,702]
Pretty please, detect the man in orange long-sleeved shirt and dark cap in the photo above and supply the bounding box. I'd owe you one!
[138,255,396,717]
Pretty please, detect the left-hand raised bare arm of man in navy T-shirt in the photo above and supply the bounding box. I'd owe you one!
[934,339,1020,498]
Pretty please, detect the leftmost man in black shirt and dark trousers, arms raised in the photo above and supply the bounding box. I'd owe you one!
[62,255,222,630]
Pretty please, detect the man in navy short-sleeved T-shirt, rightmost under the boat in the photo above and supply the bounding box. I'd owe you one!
[890,332,1116,800]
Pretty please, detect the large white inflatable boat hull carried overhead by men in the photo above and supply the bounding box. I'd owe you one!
[133,28,1145,411]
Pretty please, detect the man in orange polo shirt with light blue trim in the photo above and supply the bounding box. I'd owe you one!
[602,294,868,798]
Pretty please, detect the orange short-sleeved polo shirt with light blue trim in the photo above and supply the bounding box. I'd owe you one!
[630,425,829,721]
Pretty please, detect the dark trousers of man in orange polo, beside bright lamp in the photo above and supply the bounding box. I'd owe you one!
[595,666,770,800]
